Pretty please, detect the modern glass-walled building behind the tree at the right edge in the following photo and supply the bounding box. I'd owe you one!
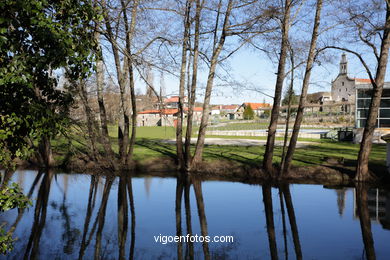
[355,82,390,128]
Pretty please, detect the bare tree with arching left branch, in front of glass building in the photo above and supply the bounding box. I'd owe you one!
[319,0,390,181]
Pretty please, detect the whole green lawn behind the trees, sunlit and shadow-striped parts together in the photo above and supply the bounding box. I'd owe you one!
[53,126,386,170]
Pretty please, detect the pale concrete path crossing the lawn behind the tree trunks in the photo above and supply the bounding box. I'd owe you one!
[162,138,316,147]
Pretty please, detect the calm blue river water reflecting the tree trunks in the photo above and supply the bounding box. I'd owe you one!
[0,171,390,259]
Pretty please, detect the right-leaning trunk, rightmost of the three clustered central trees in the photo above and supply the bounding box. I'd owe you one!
[191,0,233,167]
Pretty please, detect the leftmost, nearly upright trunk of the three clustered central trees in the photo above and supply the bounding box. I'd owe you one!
[176,0,192,170]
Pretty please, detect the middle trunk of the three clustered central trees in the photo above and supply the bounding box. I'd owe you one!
[184,0,202,171]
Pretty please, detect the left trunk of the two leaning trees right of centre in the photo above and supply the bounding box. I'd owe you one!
[263,0,291,173]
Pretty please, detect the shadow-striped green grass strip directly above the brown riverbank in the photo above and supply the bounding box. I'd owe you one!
[136,139,386,166]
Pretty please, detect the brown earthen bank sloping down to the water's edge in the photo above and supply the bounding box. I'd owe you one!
[12,154,390,186]
